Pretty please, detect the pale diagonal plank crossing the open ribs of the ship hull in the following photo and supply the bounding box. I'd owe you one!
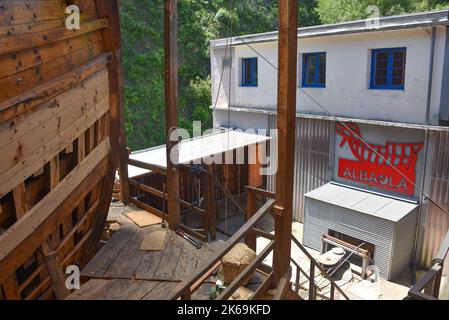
[0,141,110,270]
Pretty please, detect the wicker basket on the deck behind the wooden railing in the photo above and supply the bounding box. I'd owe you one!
[221,243,256,285]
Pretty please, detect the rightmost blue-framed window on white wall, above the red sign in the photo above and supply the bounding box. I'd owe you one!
[370,48,407,90]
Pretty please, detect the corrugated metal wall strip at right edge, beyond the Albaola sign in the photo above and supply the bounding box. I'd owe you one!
[421,132,449,274]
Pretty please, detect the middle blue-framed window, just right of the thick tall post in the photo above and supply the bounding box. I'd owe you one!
[302,52,326,88]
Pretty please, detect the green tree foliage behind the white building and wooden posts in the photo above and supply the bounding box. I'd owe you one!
[121,0,449,150]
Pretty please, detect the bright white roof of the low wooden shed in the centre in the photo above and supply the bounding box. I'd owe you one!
[128,130,270,177]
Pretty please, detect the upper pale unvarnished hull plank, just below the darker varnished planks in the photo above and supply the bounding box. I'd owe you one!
[0,68,107,173]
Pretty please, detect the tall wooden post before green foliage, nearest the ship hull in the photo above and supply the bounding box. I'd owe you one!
[164,0,180,230]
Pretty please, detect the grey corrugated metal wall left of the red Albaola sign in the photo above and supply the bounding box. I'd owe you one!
[267,115,334,222]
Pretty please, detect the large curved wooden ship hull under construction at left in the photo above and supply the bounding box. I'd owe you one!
[0,0,125,300]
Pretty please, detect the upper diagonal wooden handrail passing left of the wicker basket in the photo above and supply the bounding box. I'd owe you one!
[171,200,275,300]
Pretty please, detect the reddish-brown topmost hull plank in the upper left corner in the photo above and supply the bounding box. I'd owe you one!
[0,0,65,26]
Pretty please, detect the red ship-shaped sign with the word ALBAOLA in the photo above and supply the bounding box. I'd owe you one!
[337,123,423,196]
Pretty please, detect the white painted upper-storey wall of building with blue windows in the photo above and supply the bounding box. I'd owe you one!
[211,27,446,124]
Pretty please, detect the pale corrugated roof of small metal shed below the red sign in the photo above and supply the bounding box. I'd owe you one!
[305,183,418,222]
